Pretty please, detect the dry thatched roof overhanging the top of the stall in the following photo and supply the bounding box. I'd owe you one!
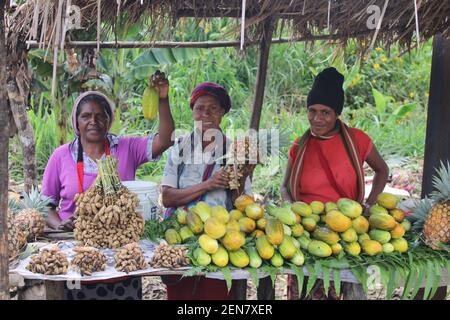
[12,0,450,47]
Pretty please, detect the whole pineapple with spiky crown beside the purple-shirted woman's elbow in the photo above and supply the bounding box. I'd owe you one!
[15,188,50,241]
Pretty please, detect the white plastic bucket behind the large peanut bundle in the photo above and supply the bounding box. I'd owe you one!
[122,181,161,220]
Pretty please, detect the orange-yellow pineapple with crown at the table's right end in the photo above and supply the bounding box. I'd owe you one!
[412,163,450,250]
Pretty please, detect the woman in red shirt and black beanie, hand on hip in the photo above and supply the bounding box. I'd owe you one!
[281,68,389,299]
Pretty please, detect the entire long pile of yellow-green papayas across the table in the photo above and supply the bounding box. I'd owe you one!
[165,193,411,268]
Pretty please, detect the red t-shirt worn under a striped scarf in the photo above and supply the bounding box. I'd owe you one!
[288,128,373,203]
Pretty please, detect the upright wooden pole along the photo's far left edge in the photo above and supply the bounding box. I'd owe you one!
[0,0,9,300]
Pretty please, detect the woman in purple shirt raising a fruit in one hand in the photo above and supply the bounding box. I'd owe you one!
[42,71,174,230]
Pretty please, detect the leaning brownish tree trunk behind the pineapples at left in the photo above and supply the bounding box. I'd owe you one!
[7,79,37,192]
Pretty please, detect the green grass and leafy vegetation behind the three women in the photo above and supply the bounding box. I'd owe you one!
[10,18,432,198]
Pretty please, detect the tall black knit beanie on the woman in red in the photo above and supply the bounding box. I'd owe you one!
[307,67,344,115]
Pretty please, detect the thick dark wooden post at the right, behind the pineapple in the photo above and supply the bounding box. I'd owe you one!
[422,34,450,197]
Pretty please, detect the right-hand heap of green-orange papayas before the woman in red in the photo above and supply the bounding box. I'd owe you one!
[290,193,411,257]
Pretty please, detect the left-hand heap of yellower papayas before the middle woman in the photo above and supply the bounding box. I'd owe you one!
[165,195,304,268]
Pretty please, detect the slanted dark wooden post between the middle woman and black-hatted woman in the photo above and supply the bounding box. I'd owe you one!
[250,17,274,130]
